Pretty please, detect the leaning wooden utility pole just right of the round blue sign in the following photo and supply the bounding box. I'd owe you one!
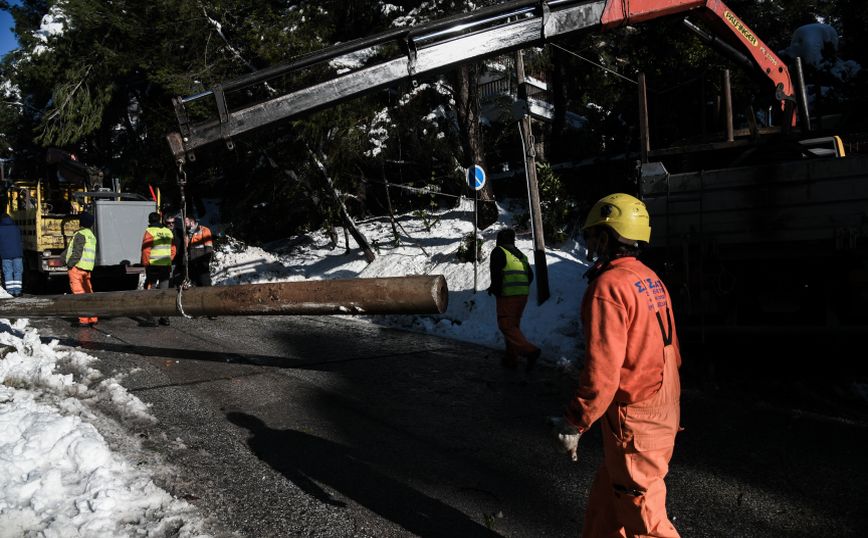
[515,51,551,304]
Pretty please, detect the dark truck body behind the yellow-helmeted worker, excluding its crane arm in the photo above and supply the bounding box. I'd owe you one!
[640,136,868,335]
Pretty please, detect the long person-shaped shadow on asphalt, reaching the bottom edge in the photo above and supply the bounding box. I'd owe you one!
[226,412,500,537]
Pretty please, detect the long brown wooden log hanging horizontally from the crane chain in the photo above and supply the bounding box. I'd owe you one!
[0,275,448,318]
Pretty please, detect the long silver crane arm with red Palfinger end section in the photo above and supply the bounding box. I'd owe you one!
[167,0,794,162]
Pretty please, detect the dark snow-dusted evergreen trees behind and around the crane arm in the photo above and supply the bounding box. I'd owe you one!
[0,0,868,242]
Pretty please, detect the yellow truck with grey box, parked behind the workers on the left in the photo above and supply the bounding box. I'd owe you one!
[4,148,157,291]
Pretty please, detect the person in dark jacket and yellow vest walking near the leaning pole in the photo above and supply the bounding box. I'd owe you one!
[488,228,541,371]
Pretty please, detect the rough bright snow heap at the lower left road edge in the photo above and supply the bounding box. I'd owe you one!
[0,319,210,538]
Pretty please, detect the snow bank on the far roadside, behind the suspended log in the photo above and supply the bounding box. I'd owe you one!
[212,199,588,366]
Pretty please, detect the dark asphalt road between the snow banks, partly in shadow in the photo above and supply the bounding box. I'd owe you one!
[27,317,868,538]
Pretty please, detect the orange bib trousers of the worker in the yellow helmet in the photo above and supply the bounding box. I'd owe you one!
[582,345,681,538]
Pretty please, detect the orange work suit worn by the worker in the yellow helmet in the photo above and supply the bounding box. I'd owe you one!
[566,257,681,538]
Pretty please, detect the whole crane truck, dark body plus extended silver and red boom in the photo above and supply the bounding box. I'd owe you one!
[167,0,868,336]
